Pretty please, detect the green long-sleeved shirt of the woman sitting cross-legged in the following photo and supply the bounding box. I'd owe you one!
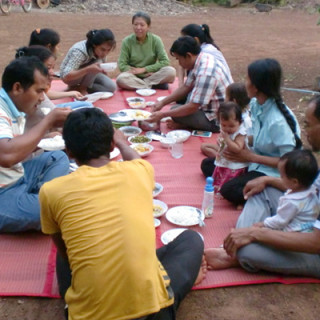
[118,32,170,76]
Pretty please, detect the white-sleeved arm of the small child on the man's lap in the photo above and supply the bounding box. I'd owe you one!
[263,198,299,230]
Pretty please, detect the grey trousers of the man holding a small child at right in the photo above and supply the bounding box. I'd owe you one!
[236,187,320,278]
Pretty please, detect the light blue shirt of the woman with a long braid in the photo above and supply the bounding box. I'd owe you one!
[248,98,300,177]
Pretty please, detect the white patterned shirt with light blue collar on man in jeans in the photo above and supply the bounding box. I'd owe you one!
[0,88,25,188]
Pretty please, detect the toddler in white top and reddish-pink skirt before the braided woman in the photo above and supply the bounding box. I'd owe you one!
[213,102,248,194]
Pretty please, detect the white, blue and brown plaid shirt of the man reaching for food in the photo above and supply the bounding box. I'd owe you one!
[185,52,233,121]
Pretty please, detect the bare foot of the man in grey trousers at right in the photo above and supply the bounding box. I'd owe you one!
[204,248,239,270]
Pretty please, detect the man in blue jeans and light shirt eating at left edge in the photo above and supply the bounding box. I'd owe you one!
[0,57,71,232]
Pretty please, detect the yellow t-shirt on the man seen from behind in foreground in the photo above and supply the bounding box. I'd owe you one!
[39,159,173,320]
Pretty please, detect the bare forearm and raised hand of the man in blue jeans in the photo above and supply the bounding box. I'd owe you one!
[0,108,71,168]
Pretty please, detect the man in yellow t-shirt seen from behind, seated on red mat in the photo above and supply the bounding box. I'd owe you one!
[39,108,203,320]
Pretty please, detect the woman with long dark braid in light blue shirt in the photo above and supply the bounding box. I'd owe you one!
[220,59,301,205]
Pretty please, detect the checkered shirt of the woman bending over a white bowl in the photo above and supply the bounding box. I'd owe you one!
[60,40,105,78]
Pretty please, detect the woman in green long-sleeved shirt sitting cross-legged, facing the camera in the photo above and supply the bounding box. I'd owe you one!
[117,12,176,90]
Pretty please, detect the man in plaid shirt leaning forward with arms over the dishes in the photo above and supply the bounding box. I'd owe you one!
[148,36,233,132]
